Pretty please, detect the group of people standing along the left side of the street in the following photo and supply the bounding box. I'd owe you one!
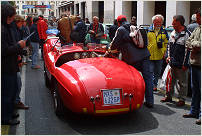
[1,3,48,125]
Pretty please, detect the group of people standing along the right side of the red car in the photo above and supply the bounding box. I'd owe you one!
[109,9,201,124]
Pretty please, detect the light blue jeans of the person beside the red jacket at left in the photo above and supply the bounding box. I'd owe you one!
[31,42,39,67]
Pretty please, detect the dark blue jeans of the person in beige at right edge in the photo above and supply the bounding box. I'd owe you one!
[190,65,201,117]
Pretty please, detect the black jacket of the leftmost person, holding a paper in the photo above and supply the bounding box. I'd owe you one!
[1,23,22,75]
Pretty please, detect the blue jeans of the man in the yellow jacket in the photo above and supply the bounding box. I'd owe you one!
[150,60,163,88]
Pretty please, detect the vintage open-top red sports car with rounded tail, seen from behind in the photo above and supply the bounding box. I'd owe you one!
[43,28,145,115]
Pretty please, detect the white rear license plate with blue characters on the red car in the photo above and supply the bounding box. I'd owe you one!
[102,89,121,105]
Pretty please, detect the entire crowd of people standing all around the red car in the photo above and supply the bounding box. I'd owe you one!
[1,4,201,125]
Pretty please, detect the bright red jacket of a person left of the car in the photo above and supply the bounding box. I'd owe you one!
[37,17,48,40]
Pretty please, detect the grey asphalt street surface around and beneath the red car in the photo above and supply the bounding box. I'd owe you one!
[2,51,201,135]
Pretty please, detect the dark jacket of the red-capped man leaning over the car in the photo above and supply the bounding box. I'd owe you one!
[111,22,150,65]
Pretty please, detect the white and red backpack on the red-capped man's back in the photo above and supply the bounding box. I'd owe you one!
[122,25,147,49]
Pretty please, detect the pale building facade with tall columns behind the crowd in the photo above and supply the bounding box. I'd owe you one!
[56,0,201,27]
